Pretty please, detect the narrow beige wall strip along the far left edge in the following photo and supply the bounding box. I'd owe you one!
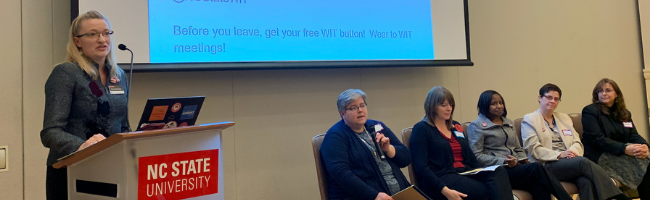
[0,0,23,199]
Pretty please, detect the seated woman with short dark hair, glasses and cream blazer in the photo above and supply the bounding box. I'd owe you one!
[521,83,629,200]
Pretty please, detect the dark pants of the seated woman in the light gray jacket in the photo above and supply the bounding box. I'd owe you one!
[505,163,573,200]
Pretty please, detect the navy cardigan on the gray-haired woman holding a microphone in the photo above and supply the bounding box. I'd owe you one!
[320,119,411,200]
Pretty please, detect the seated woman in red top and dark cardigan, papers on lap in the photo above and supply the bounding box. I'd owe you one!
[410,86,513,200]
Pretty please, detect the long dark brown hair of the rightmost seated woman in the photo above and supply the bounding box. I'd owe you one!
[591,78,630,122]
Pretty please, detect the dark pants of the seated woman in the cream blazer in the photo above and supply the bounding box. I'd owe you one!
[545,156,622,200]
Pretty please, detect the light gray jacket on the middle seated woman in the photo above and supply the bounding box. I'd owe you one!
[467,114,527,166]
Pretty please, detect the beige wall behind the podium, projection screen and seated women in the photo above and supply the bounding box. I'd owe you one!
[5,0,648,200]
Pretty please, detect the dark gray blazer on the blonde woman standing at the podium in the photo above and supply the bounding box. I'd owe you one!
[41,62,130,166]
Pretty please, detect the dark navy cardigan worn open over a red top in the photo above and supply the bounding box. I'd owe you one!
[410,121,481,196]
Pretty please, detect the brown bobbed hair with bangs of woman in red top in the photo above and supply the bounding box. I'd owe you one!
[424,86,456,130]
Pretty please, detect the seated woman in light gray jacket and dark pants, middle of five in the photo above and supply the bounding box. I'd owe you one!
[467,90,573,200]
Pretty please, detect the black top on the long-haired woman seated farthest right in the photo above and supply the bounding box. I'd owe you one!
[582,104,648,163]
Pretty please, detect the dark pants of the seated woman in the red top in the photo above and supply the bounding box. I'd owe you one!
[429,167,513,200]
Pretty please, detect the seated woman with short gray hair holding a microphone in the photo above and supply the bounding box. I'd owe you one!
[320,89,411,200]
